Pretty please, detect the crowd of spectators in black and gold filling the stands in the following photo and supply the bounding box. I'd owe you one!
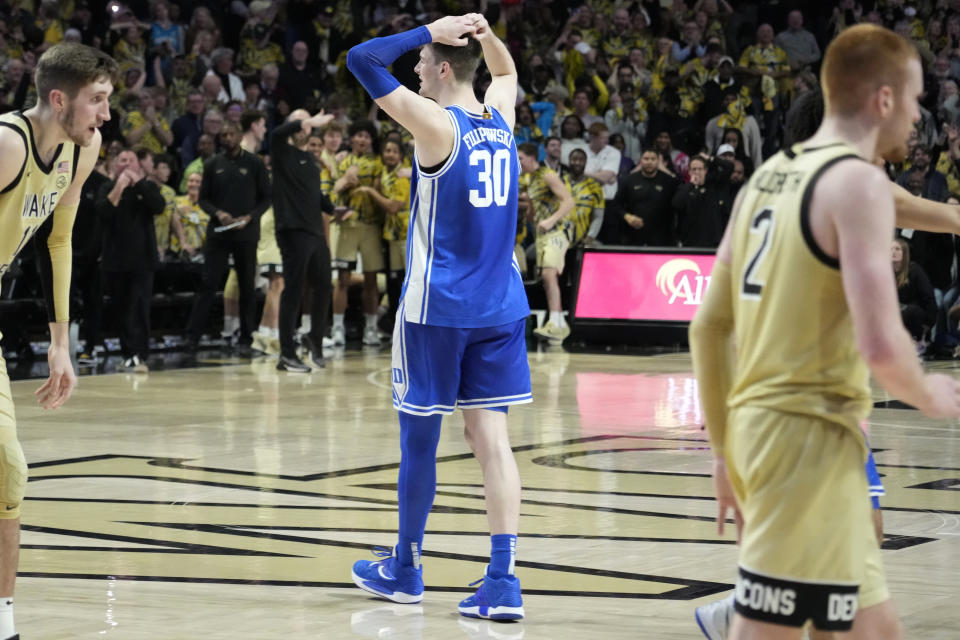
[0,0,960,356]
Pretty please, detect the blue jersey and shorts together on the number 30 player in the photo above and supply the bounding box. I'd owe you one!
[392,105,532,415]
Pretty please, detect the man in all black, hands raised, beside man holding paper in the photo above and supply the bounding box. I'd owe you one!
[270,109,333,373]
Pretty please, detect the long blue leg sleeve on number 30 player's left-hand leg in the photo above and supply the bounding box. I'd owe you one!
[397,411,443,567]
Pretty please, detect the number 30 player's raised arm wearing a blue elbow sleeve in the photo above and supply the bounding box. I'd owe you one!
[347,16,475,164]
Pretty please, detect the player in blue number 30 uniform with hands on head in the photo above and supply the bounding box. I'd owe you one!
[347,14,532,620]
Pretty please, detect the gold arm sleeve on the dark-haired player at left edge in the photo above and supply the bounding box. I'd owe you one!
[37,204,78,322]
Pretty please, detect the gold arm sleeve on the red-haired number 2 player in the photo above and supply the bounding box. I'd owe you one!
[690,260,733,457]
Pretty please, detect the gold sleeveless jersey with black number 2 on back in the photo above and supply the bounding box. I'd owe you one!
[729,144,870,434]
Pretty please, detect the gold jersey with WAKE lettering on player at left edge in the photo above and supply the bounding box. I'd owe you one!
[0,112,80,275]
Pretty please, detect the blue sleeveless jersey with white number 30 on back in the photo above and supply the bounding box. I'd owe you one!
[401,105,530,328]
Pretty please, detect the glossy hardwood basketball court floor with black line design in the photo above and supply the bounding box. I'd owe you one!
[7,350,960,640]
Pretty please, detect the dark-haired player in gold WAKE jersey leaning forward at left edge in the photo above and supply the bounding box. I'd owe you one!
[0,43,117,639]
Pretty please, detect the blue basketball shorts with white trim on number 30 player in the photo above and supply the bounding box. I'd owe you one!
[392,314,533,416]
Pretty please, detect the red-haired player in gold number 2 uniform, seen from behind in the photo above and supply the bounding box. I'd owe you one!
[690,25,960,640]
